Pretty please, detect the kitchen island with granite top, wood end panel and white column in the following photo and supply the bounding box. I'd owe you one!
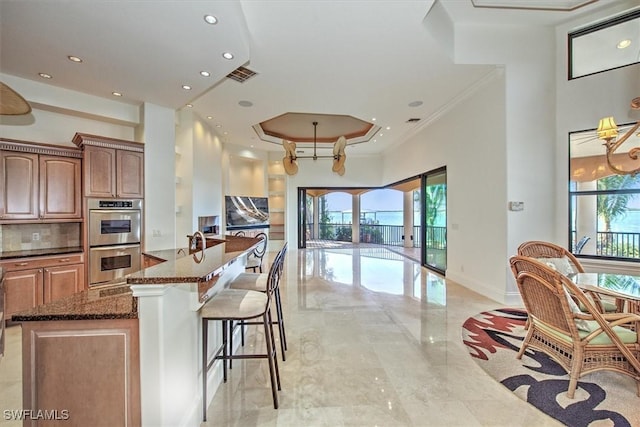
[12,237,259,426]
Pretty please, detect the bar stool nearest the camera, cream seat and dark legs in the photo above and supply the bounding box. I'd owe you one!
[200,269,281,421]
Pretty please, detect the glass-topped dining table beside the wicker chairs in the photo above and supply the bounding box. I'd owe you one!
[568,273,640,314]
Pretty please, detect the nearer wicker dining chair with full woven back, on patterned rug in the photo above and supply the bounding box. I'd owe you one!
[510,256,640,399]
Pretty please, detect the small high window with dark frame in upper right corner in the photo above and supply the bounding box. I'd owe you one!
[569,9,640,80]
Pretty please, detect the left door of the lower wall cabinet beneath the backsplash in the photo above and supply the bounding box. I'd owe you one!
[4,268,43,319]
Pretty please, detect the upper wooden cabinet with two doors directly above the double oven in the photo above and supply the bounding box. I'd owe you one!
[73,133,144,199]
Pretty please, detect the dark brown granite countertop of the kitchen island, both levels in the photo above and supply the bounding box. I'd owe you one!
[11,236,260,322]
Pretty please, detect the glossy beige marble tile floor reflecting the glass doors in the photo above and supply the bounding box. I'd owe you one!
[0,247,560,427]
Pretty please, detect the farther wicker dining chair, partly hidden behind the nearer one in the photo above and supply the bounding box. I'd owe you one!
[518,240,623,313]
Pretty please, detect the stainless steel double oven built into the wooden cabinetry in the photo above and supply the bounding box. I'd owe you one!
[87,199,142,286]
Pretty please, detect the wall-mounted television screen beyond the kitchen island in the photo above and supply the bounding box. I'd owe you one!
[224,196,269,230]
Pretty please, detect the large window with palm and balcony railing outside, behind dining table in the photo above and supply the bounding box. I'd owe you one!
[569,126,640,261]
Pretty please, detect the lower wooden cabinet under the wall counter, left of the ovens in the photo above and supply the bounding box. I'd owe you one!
[0,254,84,319]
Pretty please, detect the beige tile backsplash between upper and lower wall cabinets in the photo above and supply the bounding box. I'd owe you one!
[0,222,82,252]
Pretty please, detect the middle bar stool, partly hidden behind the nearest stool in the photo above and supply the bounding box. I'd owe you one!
[229,243,288,362]
